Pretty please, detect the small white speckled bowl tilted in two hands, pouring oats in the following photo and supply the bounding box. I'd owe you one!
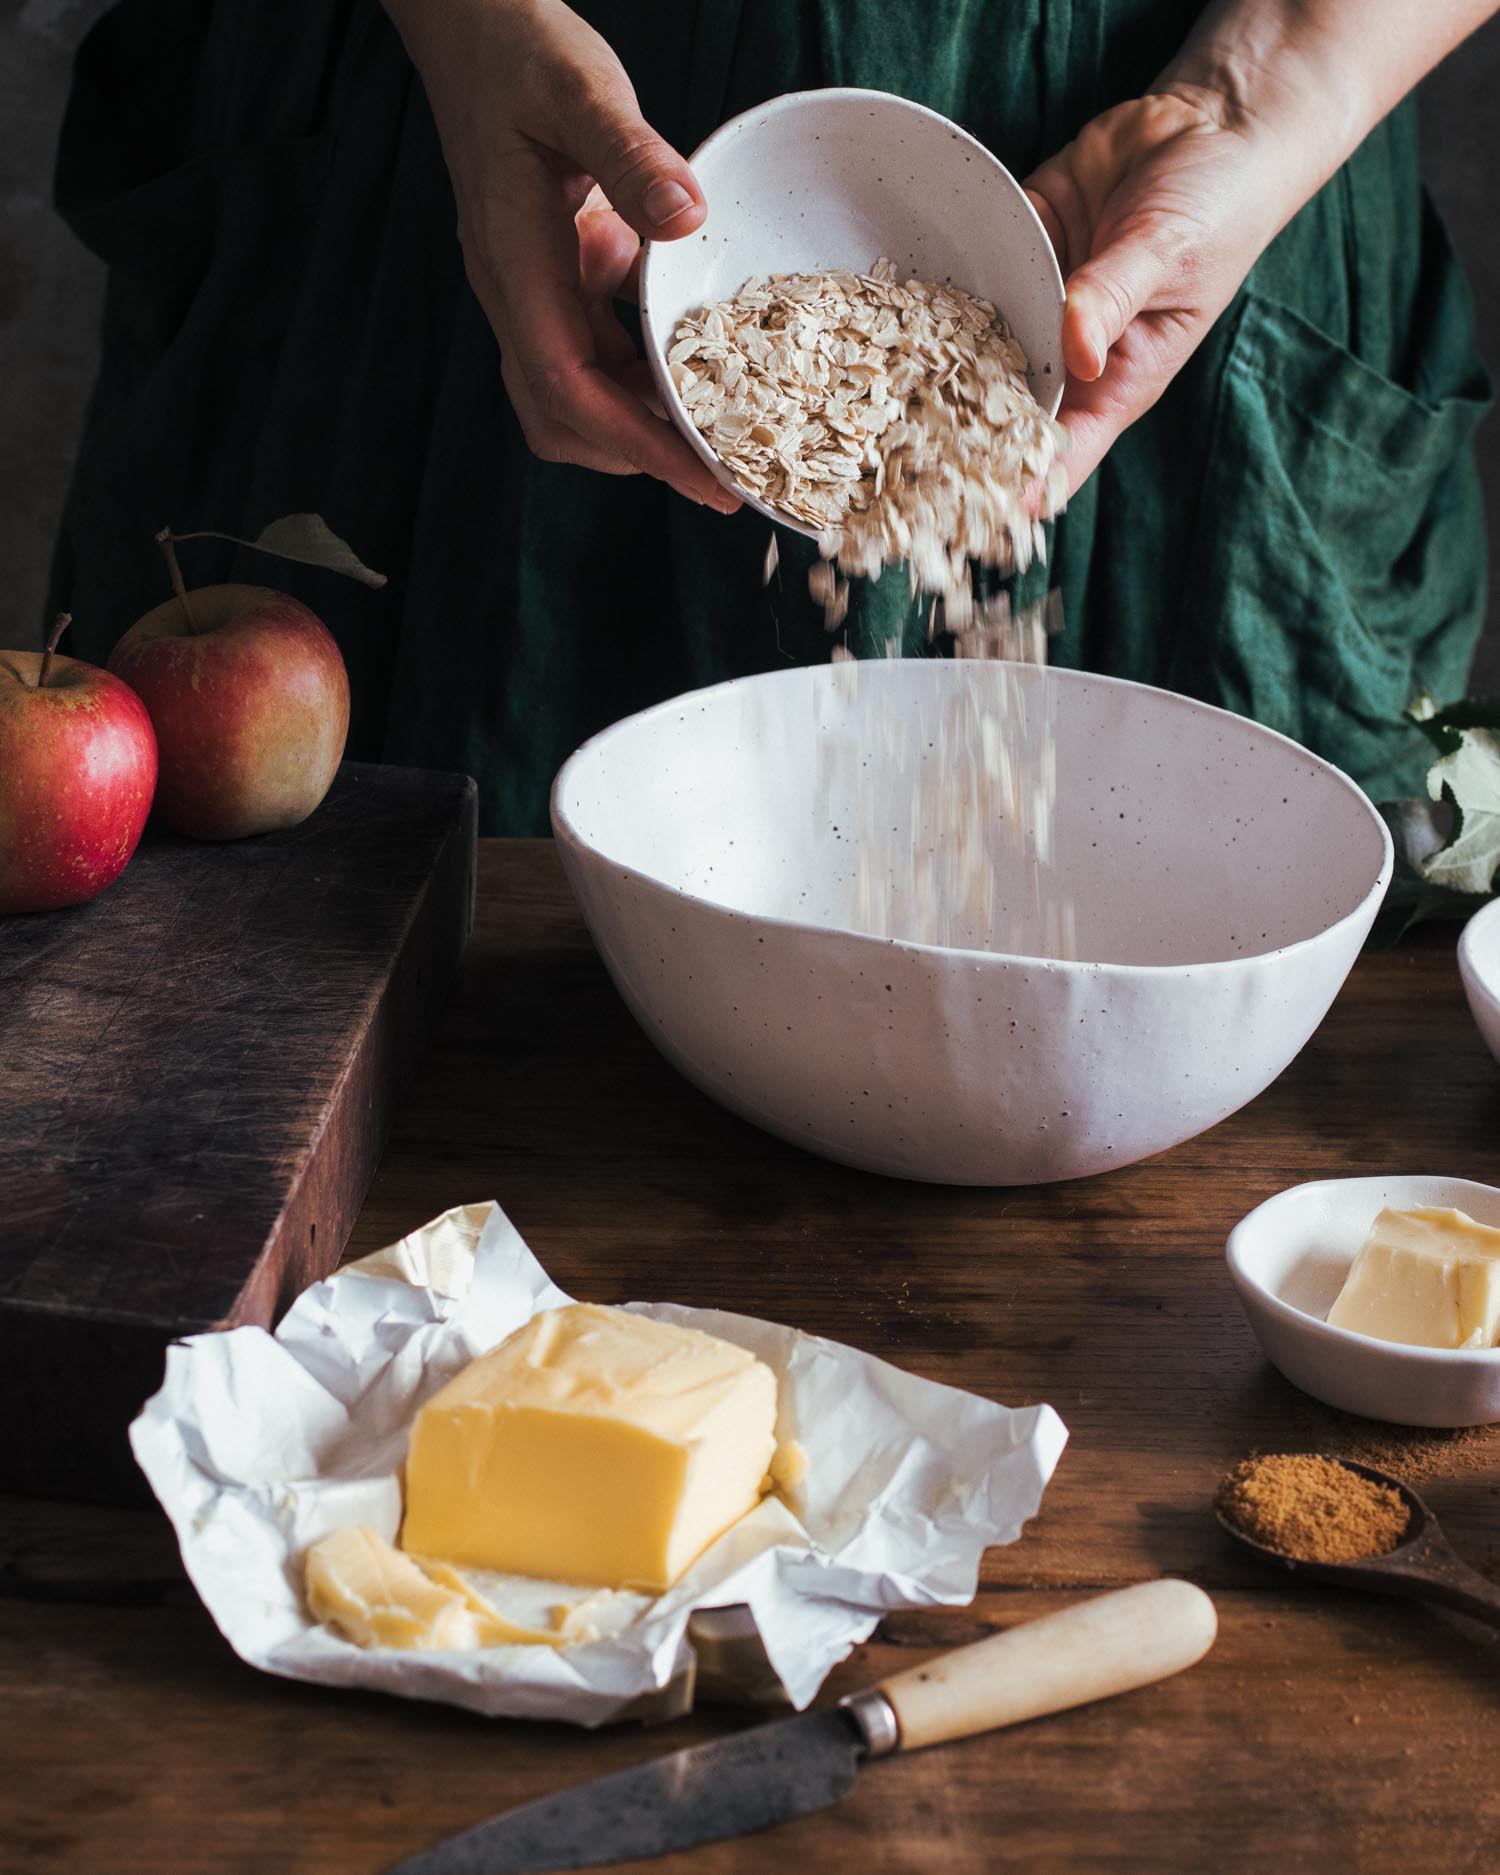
[639,88,1063,534]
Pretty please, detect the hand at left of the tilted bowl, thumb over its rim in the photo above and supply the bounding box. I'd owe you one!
[386,0,739,514]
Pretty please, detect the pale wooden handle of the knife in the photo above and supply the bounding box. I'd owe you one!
[879,1577,1219,1751]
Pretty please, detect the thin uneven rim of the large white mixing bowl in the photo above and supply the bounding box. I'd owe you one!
[548,658,1395,982]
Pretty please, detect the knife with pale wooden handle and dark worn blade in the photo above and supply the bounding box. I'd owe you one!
[390,1577,1217,1875]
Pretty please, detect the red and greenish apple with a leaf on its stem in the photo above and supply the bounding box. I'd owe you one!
[109,585,349,840]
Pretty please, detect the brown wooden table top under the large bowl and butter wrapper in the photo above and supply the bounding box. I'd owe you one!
[0,842,1500,1875]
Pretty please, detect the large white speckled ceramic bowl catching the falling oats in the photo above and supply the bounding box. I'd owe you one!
[553,658,1391,1185]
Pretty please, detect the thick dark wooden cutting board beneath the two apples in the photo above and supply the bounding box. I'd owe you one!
[0,763,476,1500]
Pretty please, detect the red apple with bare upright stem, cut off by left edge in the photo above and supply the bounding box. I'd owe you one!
[0,613,156,913]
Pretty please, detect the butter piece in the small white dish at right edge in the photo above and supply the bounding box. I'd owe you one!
[1328,1208,1500,1348]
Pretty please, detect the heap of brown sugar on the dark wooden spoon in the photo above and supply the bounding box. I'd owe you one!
[1213,1451,1408,1562]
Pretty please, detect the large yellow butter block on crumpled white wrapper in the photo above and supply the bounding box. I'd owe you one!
[401,1303,776,1594]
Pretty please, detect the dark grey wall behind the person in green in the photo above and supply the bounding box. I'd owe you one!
[0,0,1500,690]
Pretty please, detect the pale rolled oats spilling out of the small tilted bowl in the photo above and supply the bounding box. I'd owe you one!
[668,259,1067,630]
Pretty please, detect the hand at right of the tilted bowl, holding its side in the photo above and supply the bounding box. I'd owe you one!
[1026,92,1298,489]
